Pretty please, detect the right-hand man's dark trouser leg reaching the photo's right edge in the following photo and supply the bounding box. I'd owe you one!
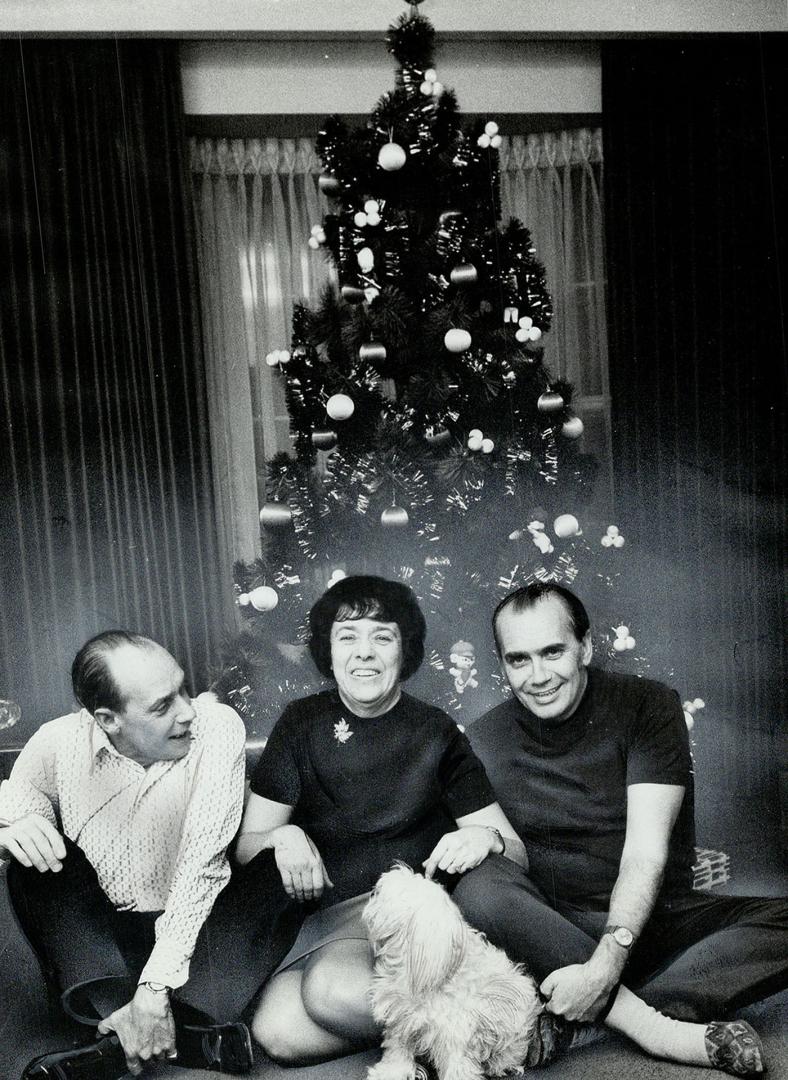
[624,892,788,1021]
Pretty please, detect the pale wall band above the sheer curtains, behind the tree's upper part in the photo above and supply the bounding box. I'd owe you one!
[181,40,601,116]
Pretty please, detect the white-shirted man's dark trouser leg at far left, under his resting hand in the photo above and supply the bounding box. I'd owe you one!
[8,839,141,991]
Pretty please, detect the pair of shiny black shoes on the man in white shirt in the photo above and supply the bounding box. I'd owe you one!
[22,1024,254,1080]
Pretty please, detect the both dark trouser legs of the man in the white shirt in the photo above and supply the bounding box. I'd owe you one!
[8,839,303,1023]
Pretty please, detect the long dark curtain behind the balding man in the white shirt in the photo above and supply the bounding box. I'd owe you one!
[0,40,221,741]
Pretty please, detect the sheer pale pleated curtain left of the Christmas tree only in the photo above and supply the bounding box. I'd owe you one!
[191,138,330,565]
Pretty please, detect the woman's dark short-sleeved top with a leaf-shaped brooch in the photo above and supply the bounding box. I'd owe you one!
[252,689,495,906]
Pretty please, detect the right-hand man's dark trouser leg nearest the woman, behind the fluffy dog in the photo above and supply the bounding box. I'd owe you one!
[452,855,597,982]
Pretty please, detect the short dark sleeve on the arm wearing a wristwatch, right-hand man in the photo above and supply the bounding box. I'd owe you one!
[626,683,692,787]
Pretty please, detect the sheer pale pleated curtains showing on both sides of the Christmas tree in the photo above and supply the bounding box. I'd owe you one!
[191,129,609,565]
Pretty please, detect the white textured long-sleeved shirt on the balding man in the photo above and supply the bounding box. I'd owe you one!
[0,694,245,987]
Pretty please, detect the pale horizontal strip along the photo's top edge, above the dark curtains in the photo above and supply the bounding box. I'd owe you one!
[0,0,788,38]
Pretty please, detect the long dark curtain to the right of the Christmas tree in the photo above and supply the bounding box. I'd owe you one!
[602,35,788,791]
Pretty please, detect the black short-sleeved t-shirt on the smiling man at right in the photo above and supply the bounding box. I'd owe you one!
[468,667,695,910]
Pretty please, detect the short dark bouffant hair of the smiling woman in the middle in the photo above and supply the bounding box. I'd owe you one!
[309,573,426,679]
